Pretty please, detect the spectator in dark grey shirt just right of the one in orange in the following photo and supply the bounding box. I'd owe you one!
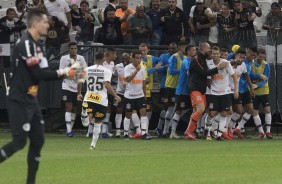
[127,5,152,45]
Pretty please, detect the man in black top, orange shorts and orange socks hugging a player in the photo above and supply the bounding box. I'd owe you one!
[185,42,228,140]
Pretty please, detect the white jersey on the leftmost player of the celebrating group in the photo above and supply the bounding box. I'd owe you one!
[60,55,87,93]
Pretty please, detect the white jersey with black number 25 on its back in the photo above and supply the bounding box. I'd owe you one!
[84,65,112,106]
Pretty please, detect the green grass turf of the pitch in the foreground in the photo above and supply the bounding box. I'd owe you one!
[0,133,282,184]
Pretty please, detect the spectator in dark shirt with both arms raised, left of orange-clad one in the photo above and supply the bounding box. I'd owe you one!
[98,9,130,45]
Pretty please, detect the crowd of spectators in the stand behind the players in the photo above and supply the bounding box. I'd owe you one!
[0,0,282,63]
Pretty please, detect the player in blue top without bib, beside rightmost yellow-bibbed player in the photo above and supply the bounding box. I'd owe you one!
[234,48,268,139]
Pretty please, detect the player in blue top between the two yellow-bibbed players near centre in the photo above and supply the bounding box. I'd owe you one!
[155,42,177,136]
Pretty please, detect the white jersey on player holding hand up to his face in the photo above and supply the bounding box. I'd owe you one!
[124,64,146,99]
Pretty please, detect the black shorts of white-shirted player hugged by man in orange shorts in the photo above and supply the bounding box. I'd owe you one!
[208,94,231,112]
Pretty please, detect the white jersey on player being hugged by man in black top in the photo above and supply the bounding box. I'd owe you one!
[208,59,235,95]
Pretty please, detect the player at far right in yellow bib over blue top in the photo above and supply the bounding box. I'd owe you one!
[252,49,273,139]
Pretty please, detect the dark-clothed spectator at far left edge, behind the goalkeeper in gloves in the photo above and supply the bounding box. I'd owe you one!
[0,8,26,67]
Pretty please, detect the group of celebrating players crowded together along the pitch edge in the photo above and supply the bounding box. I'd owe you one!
[60,41,273,149]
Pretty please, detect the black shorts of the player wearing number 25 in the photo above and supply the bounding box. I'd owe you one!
[86,102,107,121]
